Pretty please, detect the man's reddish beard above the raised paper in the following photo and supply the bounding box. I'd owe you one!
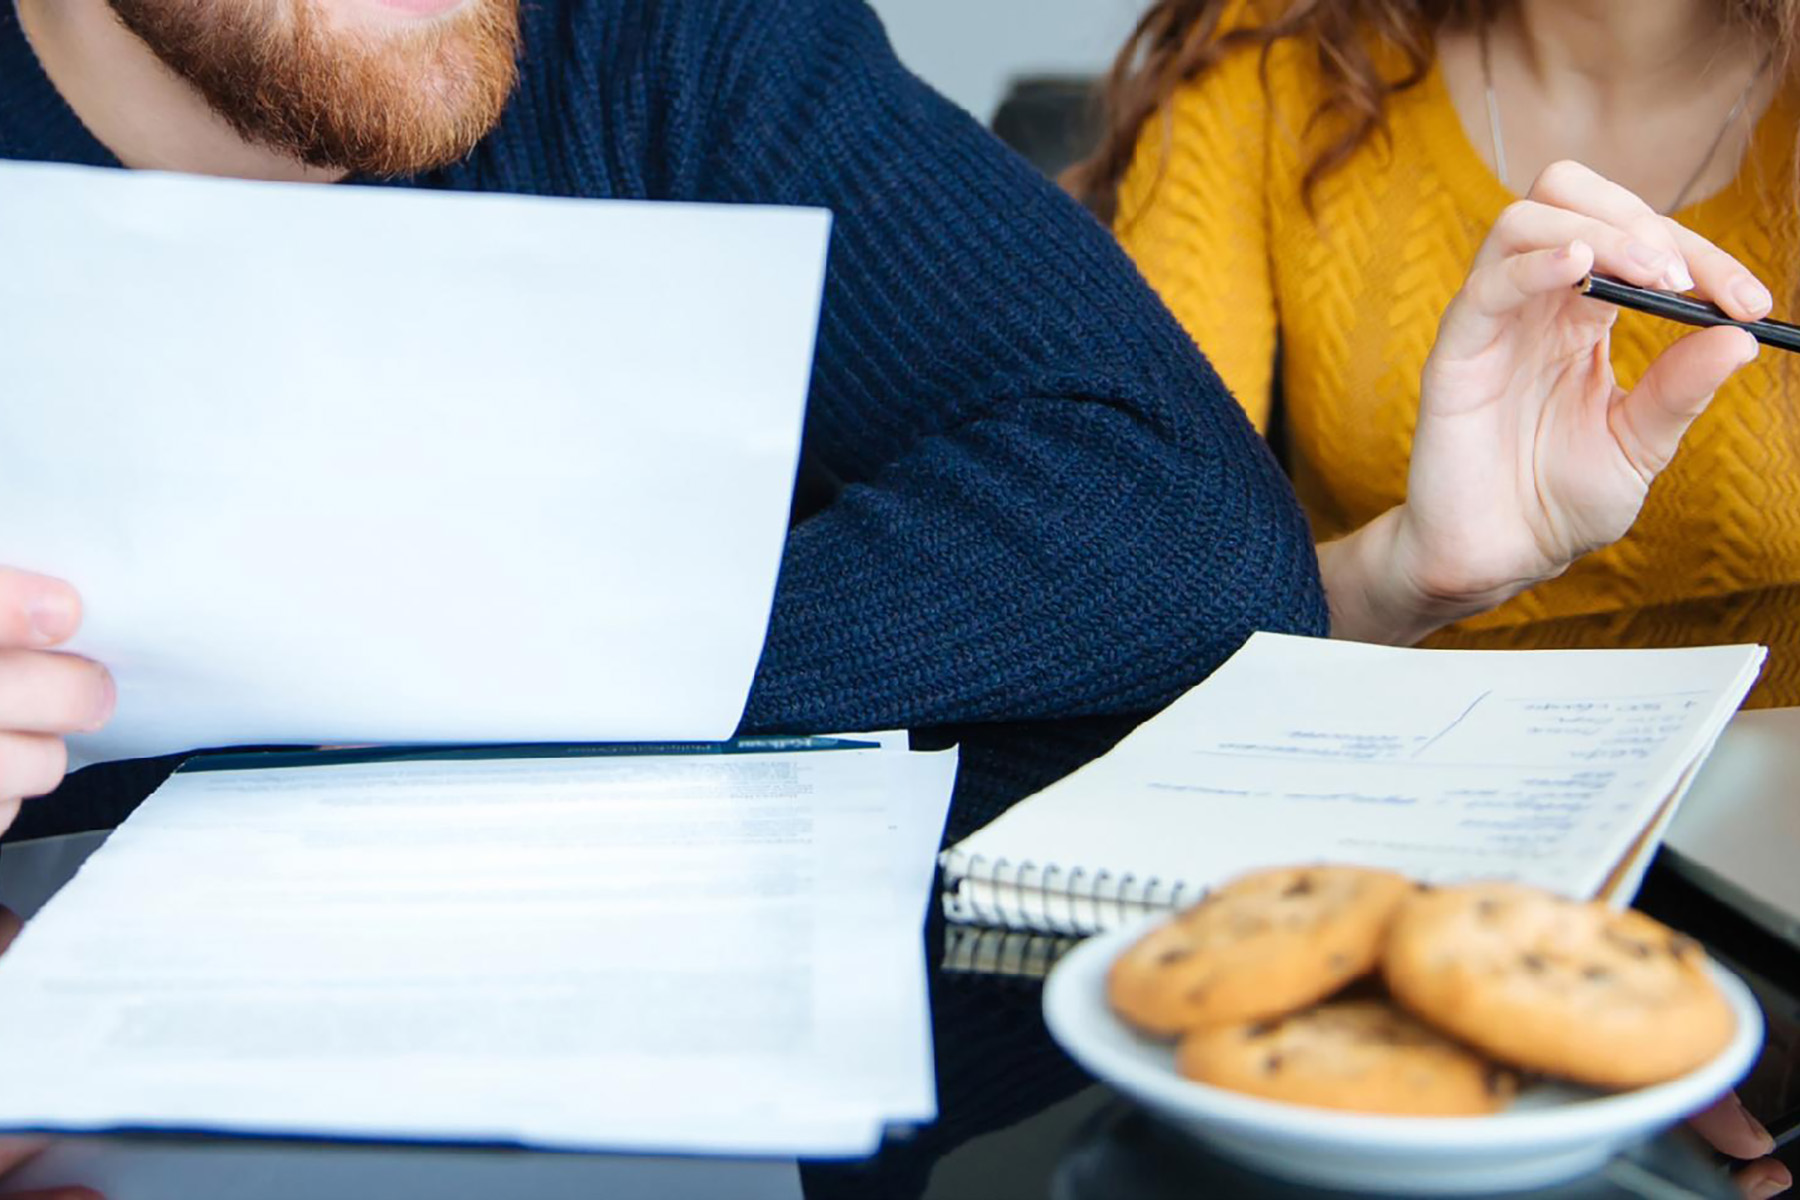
[110,0,518,176]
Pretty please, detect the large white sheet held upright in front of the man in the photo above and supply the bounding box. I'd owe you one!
[0,164,830,761]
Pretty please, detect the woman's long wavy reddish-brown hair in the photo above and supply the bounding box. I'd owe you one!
[1064,0,1800,223]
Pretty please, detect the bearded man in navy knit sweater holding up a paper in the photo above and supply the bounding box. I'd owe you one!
[0,0,1327,833]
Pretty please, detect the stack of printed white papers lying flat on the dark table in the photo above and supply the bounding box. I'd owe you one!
[0,750,956,1155]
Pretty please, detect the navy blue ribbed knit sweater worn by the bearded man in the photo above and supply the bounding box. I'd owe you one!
[0,0,1327,841]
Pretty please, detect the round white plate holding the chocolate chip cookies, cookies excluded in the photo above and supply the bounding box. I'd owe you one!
[1044,923,1762,1195]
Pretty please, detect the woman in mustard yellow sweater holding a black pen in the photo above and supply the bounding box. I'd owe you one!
[1069,0,1800,1196]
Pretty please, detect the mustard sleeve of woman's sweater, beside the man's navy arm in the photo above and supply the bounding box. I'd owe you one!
[1114,14,1278,430]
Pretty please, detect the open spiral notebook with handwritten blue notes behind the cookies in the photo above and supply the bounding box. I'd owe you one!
[941,633,1766,935]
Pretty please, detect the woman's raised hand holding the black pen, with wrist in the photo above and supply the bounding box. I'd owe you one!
[1319,162,1771,642]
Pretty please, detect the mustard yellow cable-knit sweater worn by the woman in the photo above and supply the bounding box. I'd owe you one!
[1116,25,1800,705]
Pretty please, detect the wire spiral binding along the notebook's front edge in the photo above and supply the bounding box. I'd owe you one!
[943,851,1206,937]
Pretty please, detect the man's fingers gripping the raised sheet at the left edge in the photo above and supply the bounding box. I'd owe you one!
[0,567,113,831]
